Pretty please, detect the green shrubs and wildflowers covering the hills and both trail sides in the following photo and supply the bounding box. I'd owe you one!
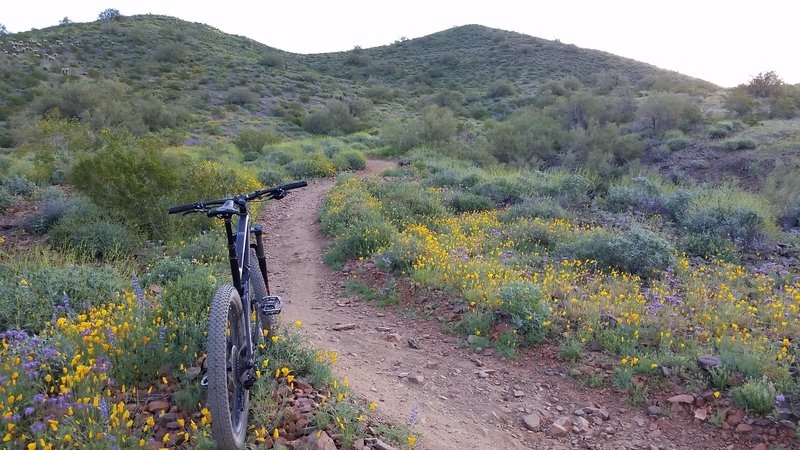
[0,9,800,448]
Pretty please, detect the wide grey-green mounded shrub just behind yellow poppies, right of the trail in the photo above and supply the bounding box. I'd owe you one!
[557,228,675,277]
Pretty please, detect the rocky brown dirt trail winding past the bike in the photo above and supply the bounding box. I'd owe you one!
[262,161,753,450]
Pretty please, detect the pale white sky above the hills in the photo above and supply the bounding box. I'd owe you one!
[0,0,800,87]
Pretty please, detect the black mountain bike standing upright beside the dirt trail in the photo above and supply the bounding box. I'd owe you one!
[168,181,308,450]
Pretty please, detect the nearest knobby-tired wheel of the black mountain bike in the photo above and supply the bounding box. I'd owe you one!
[206,285,250,450]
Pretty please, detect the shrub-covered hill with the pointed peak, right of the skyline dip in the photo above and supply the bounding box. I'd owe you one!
[305,25,715,96]
